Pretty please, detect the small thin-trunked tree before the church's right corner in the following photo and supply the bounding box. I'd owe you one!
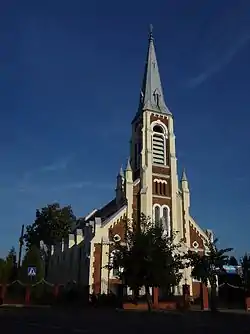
[185,239,233,311]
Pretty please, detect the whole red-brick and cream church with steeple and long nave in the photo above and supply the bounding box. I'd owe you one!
[48,31,212,296]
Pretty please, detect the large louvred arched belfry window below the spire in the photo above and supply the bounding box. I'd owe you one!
[152,124,166,165]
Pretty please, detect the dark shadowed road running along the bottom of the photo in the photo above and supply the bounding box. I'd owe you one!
[0,309,250,334]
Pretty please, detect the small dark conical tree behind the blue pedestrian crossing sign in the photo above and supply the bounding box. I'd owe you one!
[19,246,44,283]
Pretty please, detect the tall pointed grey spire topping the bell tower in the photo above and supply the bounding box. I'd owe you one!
[139,25,171,114]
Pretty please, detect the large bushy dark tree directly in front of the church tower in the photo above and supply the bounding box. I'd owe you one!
[110,216,184,310]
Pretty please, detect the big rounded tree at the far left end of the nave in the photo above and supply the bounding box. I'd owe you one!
[24,203,76,277]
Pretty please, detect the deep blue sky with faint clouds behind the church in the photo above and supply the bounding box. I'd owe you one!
[0,0,250,255]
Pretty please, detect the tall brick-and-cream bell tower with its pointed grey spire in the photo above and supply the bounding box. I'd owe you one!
[131,26,181,239]
